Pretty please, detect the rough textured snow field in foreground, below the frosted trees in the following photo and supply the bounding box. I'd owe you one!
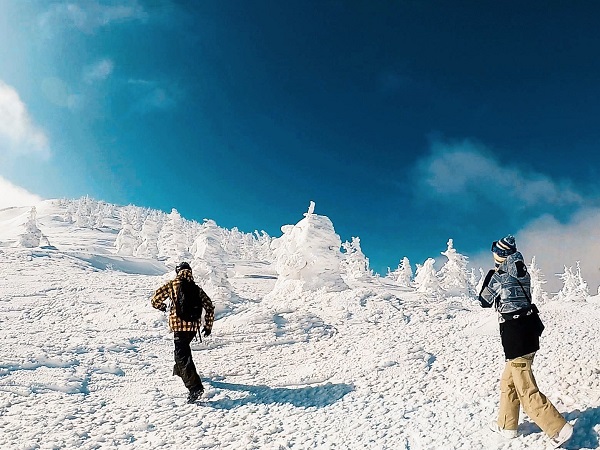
[0,249,600,449]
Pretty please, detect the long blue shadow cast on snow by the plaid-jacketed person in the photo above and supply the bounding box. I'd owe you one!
[204,380,354,409]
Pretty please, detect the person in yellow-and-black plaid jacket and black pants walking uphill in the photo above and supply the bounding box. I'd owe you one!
[151,262,215,403]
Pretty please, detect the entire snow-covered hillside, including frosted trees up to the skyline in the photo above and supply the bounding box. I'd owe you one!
[0,199,600,450]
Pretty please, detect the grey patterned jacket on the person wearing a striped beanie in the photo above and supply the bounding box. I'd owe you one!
[479,252,531,322]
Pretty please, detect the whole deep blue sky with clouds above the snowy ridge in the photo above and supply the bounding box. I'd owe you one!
[0,0,600,289]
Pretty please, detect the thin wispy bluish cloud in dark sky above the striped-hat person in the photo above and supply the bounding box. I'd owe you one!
[417,140,583,209]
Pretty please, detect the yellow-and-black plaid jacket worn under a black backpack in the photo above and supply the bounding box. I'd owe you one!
[151,269,215,331]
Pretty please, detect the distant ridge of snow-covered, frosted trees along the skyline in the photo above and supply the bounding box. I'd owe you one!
[0,197,598,303]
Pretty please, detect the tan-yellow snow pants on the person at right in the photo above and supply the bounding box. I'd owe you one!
[498,353,566,437]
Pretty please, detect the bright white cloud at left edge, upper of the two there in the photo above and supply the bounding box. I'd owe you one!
[0,80,50,158]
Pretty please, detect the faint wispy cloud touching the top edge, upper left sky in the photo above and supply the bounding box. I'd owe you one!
[39,0,148,34]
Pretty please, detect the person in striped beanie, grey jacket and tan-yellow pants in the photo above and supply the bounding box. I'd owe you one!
[479,235,573,447]
